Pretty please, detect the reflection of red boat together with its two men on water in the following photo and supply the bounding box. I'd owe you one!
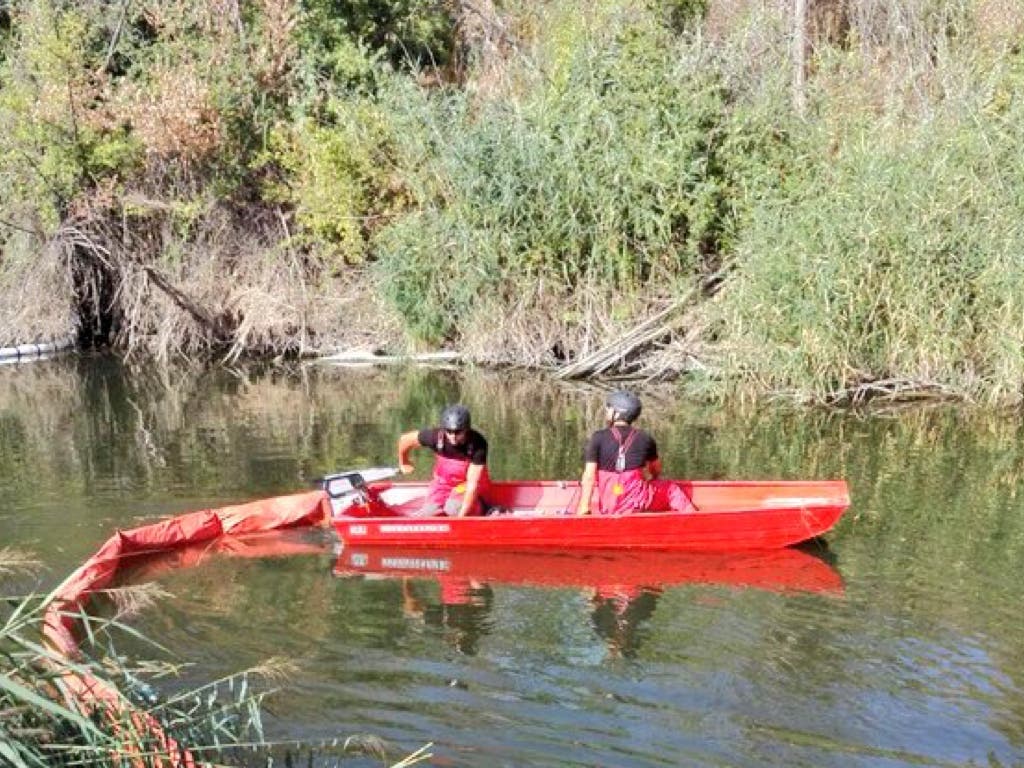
[334,547,843,657]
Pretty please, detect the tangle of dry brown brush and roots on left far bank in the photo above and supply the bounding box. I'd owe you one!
[49,191,358,361]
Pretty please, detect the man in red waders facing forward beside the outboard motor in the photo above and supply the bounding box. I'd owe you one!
[398,406,489,517]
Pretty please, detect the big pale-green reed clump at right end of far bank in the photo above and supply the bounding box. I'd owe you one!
[721,52,1024,399]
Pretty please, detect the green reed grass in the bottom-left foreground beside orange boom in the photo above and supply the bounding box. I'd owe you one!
[0,548,430,768]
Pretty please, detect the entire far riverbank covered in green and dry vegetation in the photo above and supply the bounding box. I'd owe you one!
[0,0,1024,404]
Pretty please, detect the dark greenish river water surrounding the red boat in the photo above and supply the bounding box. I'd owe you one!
[0,358,1024,766]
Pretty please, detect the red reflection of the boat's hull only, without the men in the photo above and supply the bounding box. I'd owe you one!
[334,547,843,595]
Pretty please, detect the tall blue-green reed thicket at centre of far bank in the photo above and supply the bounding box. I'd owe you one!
[377,3,728,340]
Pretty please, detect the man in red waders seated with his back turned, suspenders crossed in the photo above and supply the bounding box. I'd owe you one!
[578,391,693,515]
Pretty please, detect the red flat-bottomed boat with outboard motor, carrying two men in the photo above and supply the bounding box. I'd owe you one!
[322,469,850,551]
